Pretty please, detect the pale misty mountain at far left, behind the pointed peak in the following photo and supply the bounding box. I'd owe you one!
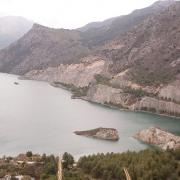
[0,16,33,49]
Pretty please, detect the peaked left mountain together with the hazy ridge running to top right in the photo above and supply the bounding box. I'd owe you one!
[0,1,173,74]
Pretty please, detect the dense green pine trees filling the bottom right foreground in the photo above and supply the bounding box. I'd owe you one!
[64,150,180,180]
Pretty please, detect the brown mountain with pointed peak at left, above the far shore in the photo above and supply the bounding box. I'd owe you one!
[0,24,89,74]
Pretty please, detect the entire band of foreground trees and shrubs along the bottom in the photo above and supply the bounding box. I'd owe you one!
[0,149,180,180]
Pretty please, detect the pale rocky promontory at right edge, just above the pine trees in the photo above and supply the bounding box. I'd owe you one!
[134,127,180,150]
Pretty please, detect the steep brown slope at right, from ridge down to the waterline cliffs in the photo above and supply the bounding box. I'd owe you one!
[87,1,180,116]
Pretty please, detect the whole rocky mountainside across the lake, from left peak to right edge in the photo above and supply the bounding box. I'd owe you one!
[0,1,180,116]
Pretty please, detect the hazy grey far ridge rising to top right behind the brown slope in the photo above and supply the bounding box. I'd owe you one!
[79,0,174,46]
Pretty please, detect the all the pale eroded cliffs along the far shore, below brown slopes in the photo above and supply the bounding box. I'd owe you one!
[24,57,180,116]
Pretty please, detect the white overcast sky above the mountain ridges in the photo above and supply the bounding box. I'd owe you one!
[0,0,158,28]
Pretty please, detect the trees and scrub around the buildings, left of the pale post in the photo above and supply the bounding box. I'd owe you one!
[0,152,57,180]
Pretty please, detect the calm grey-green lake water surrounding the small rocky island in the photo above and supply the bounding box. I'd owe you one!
[0,74,180,157]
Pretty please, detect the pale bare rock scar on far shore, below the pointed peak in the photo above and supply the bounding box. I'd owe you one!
[24,57,110,87]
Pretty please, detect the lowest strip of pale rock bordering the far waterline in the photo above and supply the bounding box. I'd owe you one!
[20,67,180,118]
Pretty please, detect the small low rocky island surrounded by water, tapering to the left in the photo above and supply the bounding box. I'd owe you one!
[74,127,119,141]
